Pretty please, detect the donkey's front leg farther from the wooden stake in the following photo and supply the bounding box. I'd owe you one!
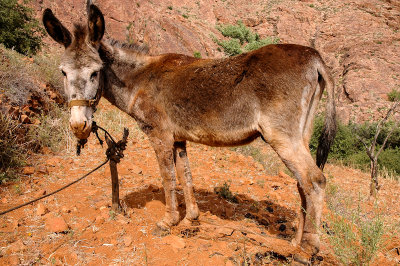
[174,142,199,225]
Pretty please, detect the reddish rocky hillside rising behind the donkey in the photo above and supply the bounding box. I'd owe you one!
[32,0,400,122]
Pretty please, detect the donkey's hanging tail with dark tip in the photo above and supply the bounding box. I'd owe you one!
[316,60,337,170]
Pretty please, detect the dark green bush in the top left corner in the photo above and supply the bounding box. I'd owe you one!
[0,0,44,55]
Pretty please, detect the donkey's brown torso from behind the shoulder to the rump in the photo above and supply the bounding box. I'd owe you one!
[152,45,323,146]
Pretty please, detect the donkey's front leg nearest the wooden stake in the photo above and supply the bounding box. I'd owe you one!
[152,139,179,230]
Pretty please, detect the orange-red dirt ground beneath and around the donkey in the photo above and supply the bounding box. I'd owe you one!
[0,101,400,265]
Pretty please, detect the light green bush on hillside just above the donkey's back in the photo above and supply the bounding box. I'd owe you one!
[214,21,279,56]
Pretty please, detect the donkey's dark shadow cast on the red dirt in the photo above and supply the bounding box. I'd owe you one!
[123,185,297,239]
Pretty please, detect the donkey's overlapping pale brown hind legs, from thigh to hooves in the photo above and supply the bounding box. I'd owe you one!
[268,135,326,254]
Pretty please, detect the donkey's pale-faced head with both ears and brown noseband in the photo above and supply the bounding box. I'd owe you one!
[43,5,104,139]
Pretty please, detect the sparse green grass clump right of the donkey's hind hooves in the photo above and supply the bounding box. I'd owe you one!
[324,186,386,265]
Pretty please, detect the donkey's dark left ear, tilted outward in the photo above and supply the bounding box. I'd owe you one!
[43,8,71,48]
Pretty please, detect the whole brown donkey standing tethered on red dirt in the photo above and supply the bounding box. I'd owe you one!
[43,5,336,258]
